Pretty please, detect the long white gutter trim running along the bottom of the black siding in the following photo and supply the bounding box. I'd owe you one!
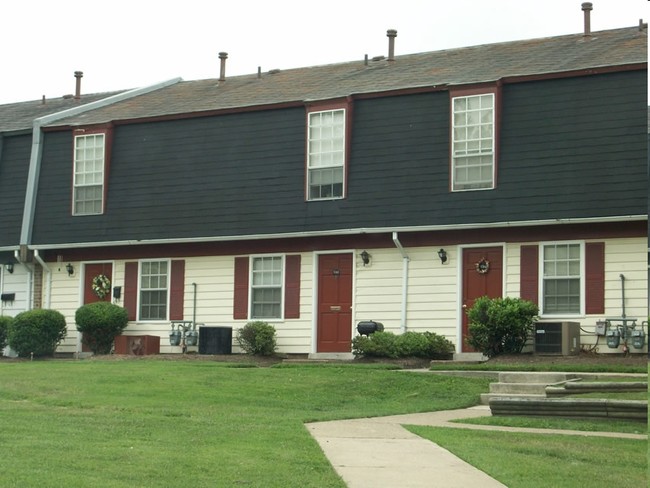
[30,215,648,250]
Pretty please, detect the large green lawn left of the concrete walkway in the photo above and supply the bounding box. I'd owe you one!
[0,359,488,488]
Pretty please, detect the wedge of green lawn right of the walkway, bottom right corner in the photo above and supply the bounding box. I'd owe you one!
[408,426,648,488]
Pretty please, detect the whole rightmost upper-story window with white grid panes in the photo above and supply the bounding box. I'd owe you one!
[451,93,496,191]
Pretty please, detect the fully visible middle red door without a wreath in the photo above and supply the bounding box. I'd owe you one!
[316,254,352,352]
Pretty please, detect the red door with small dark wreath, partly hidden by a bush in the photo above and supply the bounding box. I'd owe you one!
[462,247,503,352]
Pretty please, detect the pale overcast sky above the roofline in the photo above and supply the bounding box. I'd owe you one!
[0,0,650,103]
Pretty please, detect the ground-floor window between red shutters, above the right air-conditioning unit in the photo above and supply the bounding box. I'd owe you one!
[541,243,584,315]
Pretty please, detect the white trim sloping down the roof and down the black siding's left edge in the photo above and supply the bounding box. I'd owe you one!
[20,78,182,245]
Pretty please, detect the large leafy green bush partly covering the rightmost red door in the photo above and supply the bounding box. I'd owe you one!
[467,297,539,357]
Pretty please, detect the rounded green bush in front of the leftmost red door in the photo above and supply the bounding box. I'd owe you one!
[74,302,129,354]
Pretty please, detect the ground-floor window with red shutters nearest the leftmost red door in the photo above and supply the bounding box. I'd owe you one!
[139,260,170,320]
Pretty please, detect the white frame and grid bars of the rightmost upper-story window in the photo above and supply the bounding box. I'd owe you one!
[451,91,497,192]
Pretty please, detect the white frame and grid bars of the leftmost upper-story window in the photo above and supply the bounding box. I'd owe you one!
[72,132,106,216]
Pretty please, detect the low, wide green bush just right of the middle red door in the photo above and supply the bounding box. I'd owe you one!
[352,331,454,359]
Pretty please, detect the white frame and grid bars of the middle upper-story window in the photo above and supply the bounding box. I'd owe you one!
[306,107,347,202]
